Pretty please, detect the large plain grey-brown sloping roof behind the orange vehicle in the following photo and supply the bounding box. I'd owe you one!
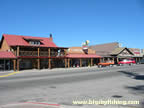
[89,42,119,56]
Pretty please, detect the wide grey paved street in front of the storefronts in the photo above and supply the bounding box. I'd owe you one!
[0,65,144,107]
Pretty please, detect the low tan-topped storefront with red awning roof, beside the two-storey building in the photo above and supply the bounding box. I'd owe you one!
[66,47,101,67]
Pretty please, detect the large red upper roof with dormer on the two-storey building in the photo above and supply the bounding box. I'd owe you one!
[2,34,57,47]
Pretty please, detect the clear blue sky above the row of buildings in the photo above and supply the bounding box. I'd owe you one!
[0,0,144,48]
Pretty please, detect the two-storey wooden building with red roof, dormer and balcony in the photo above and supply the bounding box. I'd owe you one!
[0,34,67,71]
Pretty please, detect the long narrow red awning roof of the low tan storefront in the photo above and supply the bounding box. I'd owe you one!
[66,54,101,58]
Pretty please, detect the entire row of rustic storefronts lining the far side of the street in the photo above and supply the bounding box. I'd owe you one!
[0,34,144,71]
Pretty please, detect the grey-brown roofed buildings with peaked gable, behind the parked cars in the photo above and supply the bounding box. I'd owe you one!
[89,42,143,64]
